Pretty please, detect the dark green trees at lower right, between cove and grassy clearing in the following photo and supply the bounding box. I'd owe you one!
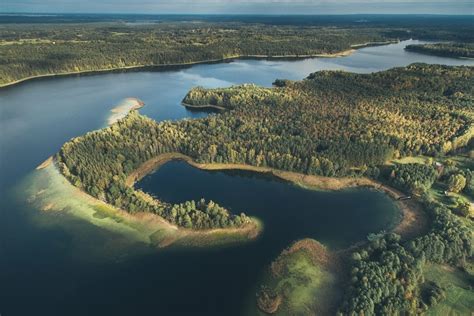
[340,159,473,315]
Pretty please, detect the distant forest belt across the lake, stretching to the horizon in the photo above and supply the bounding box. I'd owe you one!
[0,21,473,85]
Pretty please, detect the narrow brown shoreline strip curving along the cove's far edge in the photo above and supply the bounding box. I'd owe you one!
[125,153,428,239]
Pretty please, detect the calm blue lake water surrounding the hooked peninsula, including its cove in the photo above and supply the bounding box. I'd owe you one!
[0,41,474,316]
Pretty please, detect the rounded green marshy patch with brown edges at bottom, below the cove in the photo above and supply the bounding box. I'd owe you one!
[258,239,341,315]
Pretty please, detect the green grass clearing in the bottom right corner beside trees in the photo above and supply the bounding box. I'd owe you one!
[424,264,474,316]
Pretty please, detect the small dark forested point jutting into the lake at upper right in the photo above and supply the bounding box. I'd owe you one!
[405,43,474,58]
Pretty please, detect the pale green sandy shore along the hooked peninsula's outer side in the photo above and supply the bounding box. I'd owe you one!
[28,157,263,248]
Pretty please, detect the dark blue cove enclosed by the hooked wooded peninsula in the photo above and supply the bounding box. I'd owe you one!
[135,160,399,251]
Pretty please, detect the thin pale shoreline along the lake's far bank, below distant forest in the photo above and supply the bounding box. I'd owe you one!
[0,41,400,89]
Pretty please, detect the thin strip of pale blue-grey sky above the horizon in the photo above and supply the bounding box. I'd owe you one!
[0,0,474,15]
